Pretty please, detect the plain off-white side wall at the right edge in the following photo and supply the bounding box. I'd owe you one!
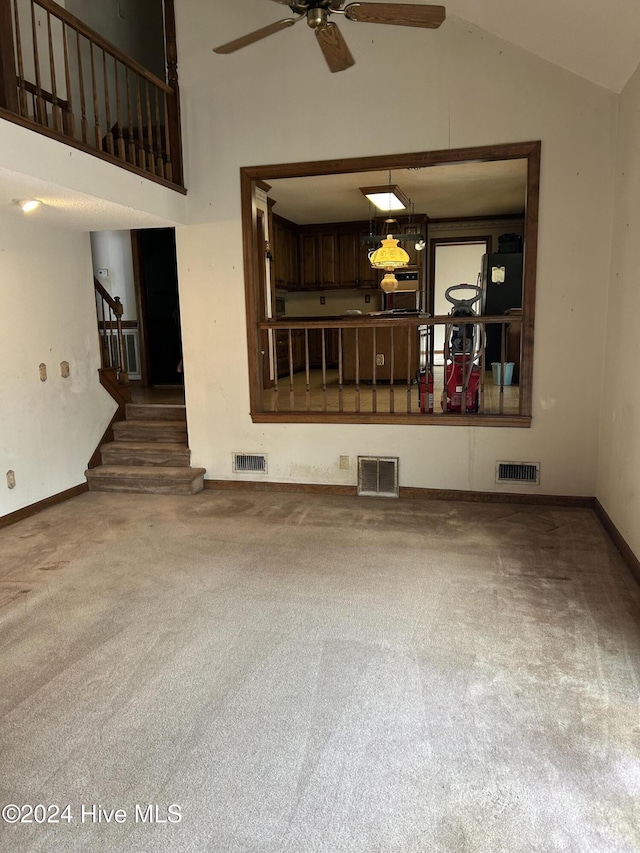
[596,60,640,558]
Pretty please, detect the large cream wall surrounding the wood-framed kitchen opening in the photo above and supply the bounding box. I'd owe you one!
[176,6,615,495]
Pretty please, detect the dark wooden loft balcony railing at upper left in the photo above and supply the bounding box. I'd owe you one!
[0,0,183,188]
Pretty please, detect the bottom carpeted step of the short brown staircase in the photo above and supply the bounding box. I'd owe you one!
[85,465,206,495]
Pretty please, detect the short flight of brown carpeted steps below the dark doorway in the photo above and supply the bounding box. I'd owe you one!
[85,403,206,495]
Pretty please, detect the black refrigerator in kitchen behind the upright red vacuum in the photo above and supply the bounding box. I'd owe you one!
[481,252,522,362]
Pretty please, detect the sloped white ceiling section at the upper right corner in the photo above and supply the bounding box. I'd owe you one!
[440,0,640,92]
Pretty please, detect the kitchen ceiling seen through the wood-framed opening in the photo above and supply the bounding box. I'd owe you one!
[265,160,527,225]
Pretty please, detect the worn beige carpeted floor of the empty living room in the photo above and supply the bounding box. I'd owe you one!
[0,491,640,853]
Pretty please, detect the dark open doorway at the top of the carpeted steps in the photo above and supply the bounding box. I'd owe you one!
[132,228,183,385]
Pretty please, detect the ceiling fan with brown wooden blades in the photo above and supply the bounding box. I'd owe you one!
[213,0,445,72]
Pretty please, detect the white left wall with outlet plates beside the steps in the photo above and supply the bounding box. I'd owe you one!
[0,215,115,516]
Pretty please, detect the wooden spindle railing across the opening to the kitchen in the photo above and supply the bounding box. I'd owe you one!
[252,315,531,426]
